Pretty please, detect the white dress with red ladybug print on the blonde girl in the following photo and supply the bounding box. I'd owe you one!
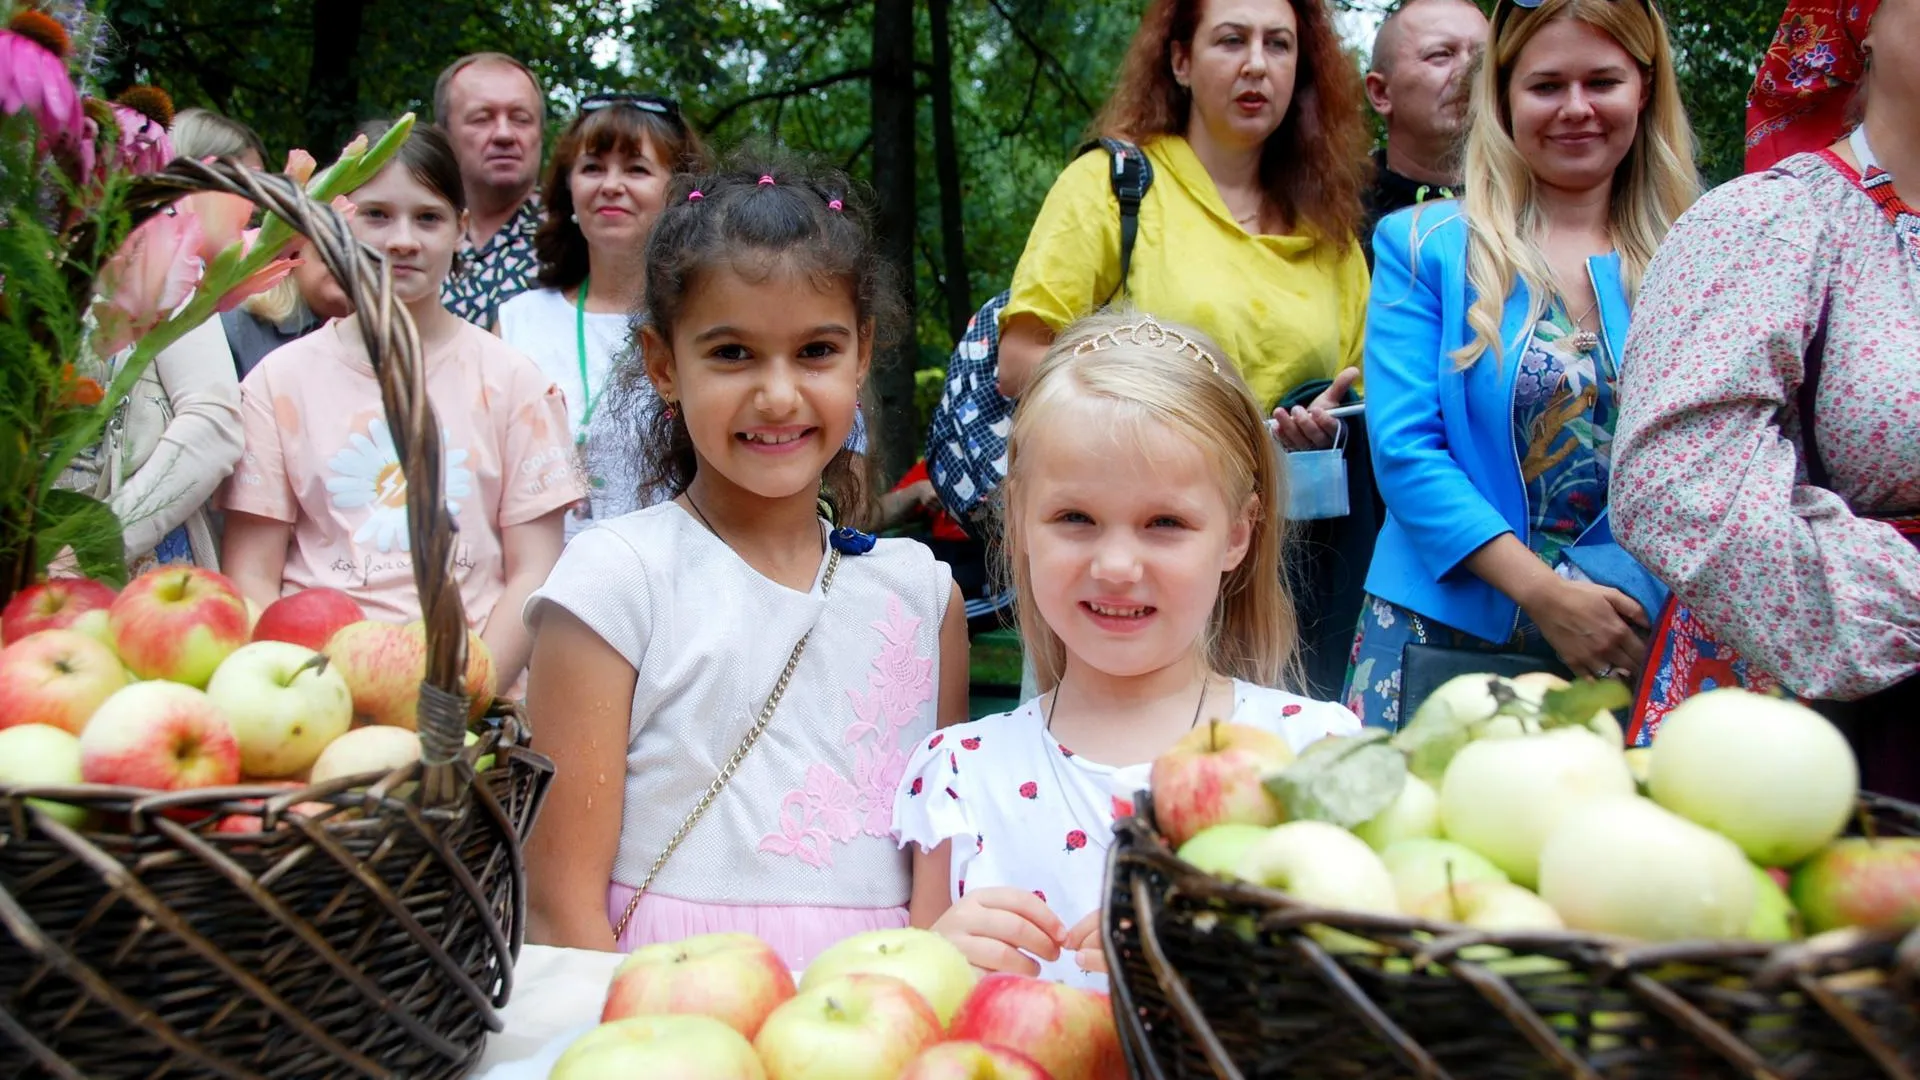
[893,678,1359,990]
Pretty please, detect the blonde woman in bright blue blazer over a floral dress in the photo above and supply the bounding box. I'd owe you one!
[1344,0,1697,726]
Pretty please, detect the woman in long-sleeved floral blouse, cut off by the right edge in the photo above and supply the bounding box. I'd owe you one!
[1613,0,1920,796]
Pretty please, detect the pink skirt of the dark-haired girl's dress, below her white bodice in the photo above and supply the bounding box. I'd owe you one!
[607,882,906,970]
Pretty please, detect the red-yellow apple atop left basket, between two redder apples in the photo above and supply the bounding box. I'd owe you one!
[108,567,248,686]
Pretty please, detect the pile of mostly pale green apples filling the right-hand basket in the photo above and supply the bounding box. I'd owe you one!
[1152,675,1920,945]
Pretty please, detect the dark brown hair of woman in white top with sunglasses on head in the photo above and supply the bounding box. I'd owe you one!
[534,106,712,288]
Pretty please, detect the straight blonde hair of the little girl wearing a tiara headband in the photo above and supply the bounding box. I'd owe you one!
[1000,311,1300,692]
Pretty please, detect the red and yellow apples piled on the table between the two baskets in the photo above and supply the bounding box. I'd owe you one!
[549,930,1127,1080]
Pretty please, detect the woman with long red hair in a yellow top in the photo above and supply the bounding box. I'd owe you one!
[998,0,1367,411]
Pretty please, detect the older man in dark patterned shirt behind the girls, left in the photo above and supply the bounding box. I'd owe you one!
[434,52,547,329]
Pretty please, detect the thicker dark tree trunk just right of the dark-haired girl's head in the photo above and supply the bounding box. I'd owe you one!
[870,0,924,484]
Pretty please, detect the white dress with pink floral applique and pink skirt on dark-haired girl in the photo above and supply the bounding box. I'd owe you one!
[526,502,952,970]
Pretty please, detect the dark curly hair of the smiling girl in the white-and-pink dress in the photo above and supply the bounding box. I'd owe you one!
[609,150,908,527]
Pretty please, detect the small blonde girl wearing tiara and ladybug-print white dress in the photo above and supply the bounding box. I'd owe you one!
[893,313,1359,986]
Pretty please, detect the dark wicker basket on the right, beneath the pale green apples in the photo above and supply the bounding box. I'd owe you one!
[1104,794,1920,1080]
